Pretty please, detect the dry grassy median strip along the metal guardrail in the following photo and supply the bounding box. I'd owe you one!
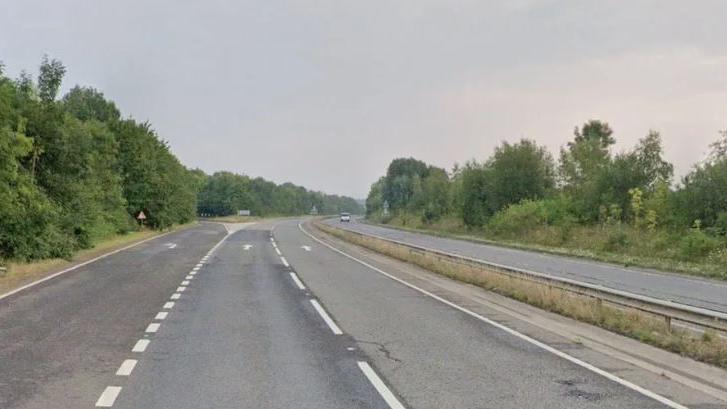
[315,223,727,368]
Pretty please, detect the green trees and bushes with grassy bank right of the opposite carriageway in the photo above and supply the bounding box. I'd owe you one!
[366,121,727,275]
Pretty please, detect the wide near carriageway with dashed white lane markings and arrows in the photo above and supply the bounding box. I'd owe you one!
[0,220,724,409]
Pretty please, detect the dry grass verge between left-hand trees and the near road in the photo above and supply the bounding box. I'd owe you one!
[0,223,197,294]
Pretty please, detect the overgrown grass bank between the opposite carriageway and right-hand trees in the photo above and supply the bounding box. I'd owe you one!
[372,214,727,280]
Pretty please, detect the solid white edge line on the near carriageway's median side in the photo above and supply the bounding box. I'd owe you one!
[298,223,689,409]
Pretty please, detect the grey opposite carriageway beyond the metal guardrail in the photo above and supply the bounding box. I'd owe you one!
[326,219,727,313]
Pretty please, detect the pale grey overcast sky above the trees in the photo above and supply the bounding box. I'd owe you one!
[0,0,727,197]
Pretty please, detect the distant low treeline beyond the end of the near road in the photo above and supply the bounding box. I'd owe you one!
[199,172,363,216]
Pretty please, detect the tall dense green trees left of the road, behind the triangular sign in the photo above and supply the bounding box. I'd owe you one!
[0,58,196,260]
